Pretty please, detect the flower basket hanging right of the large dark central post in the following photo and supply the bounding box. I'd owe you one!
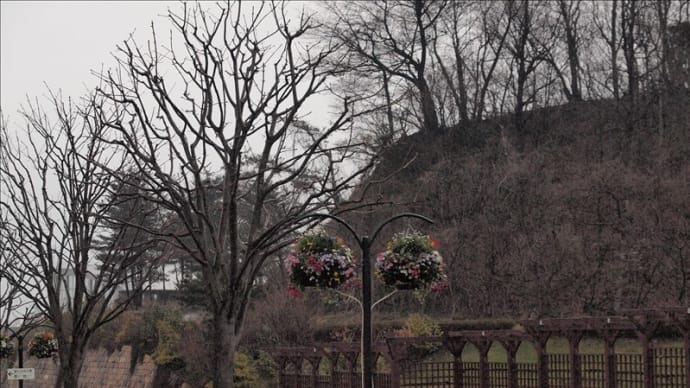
[376,232,446,290]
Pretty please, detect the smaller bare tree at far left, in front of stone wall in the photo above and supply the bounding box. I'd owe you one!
[0,94,157,388]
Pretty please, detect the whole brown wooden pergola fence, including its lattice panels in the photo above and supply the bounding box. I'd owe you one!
[271,308,690,388]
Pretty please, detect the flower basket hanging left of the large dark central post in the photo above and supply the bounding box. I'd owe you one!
[286,232,355,289]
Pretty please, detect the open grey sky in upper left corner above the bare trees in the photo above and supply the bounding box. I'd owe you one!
[0,0,178,122]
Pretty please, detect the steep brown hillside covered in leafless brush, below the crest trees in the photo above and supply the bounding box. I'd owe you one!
[342,93,690,318]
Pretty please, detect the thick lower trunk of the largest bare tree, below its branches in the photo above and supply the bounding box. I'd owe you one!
[210,311,238,388]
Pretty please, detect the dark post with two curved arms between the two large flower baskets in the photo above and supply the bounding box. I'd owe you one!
[300,213,433,388]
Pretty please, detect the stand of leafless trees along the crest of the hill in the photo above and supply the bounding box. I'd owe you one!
[323,0,690,144]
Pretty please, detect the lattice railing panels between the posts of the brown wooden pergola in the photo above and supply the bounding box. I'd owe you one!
[280,348,688,388]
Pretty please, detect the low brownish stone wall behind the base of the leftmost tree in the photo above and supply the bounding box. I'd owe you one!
[1,346,157,388]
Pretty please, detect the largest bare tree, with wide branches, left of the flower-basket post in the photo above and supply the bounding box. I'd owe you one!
[100,2,367,387]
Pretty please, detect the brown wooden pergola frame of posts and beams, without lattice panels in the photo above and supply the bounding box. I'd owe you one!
[272,307,690,388]
